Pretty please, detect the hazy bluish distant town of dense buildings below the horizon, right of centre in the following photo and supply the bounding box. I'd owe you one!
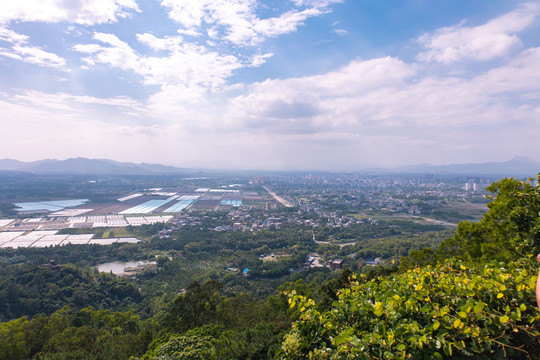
[267,174,493,215]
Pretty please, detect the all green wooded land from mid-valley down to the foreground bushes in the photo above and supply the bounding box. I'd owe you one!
[0,175,540,360]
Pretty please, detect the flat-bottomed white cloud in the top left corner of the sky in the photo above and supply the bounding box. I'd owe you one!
[0,0,140,25]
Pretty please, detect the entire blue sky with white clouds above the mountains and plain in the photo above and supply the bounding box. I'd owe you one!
[0,0,540,170]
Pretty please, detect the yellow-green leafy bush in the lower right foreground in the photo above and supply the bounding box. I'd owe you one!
[279,259,540,359]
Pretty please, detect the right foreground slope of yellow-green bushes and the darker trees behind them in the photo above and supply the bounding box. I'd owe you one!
[280,179,540,359]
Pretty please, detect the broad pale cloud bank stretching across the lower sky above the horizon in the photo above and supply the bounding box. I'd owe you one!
[4,42,540,169]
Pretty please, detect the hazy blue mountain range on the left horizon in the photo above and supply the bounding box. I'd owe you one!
[0,158,192,175]
